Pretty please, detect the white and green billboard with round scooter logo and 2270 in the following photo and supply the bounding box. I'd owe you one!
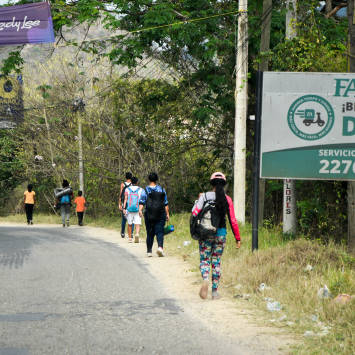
[260,72,355,180]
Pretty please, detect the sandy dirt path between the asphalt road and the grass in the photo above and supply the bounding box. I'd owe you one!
[0,223,295,355]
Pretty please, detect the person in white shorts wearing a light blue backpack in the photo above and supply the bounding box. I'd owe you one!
[123,176,142,243]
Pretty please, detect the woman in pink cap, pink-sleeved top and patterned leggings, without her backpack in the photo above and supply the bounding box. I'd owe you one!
[192,172,241,300]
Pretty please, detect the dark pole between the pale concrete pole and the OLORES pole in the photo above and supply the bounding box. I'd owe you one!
[254,0,272,227]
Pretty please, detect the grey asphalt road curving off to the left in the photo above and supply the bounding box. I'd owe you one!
[0,226,244,355]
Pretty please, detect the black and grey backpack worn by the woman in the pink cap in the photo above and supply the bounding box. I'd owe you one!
[190,195,221,240]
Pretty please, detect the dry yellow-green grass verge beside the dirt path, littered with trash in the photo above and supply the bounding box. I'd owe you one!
[0,214,355,355]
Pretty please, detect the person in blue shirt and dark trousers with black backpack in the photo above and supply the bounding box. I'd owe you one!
[139,173,169,257]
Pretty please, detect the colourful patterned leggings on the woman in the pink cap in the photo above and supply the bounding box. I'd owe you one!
[199,235,226,291]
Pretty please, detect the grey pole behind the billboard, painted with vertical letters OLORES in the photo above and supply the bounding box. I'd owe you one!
[283,0,297,235]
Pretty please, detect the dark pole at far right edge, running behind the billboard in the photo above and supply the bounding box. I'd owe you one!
[348,0,355,254]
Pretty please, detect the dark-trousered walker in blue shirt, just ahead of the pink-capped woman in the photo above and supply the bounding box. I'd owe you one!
[139,173,169,257]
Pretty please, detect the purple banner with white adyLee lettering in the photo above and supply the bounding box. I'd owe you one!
[0,2,55,46]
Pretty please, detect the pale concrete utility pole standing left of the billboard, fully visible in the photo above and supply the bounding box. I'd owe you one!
[233,0,248,224]
